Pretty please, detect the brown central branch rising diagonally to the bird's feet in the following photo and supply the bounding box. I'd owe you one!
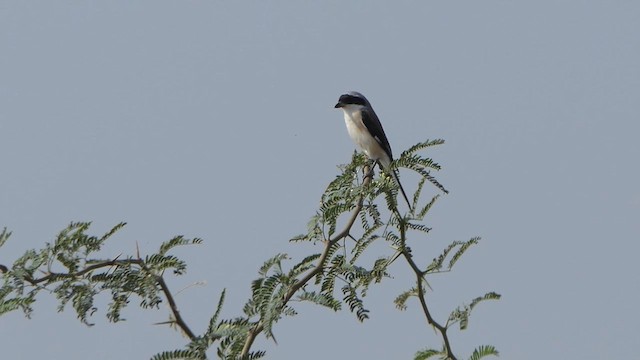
[240,165,373,358]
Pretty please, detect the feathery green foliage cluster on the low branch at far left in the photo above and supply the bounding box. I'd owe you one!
[0,222,201,325]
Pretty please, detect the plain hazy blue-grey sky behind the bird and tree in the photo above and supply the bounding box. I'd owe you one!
[0,1,640,359]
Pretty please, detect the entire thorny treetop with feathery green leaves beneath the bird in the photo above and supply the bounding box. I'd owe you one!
[0,139,500,360]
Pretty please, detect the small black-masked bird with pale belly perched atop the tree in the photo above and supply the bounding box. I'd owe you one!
[334,91,411,209]
